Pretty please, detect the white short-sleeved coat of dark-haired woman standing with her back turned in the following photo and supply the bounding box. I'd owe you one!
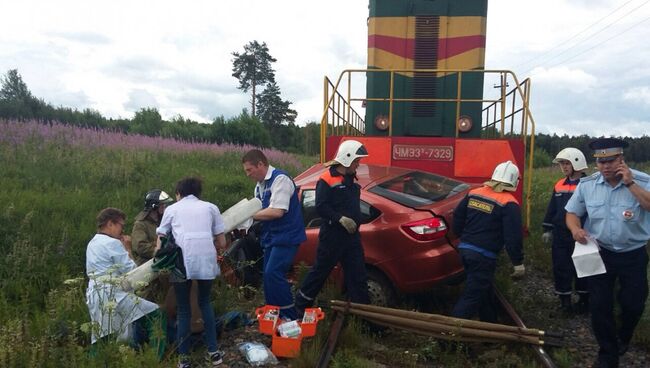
[156,195,224,280]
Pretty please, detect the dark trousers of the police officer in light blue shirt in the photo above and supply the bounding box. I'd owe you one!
[589,247,648,367]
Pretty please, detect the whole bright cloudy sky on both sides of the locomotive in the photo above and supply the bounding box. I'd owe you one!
[0,0,650,136]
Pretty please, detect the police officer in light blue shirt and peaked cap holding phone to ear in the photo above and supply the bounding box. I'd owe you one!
[565,138,650,367]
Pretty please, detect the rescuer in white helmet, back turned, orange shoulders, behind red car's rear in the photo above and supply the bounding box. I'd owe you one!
[451,161,526,322]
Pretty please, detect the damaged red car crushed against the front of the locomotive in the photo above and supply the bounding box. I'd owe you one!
[229,164,470,305]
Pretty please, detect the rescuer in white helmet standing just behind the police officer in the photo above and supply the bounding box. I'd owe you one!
[542,147,589,314]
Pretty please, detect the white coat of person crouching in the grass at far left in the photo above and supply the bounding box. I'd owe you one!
[86,234,158,343]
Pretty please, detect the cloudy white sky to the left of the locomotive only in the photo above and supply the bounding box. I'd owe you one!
[0,0,367,122]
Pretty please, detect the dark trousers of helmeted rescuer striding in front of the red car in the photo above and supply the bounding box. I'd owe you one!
[296,236,370,314]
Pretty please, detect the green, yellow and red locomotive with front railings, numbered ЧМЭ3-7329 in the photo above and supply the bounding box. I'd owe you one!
[321,0,535,227]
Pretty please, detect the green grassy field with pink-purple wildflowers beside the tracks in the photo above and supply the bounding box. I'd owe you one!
[0,120,650,367]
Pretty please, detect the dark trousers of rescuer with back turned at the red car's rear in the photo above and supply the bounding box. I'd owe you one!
[451,249,497,322]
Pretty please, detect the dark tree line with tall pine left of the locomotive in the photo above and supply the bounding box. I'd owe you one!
[0,41,320,155]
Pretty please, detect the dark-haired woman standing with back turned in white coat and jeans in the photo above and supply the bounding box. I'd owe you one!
[156,177,226,368]
